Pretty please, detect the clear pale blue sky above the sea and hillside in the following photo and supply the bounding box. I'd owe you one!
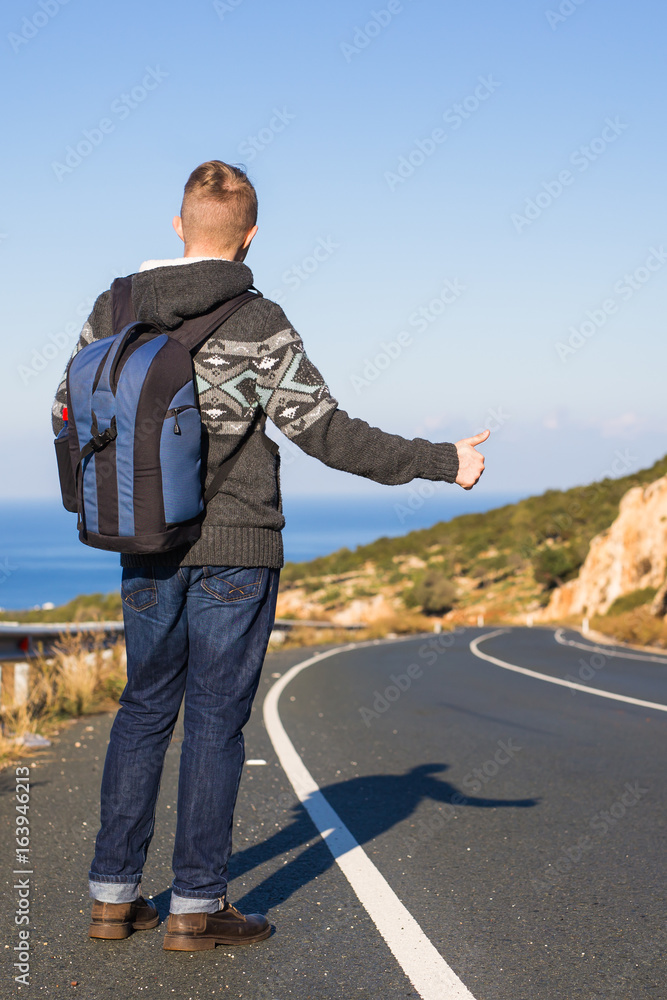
[0,0,667,497]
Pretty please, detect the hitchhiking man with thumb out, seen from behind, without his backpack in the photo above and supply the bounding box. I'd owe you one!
[53,160,489,950]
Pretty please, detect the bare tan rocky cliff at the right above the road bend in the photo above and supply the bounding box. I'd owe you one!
[540,476,667,620]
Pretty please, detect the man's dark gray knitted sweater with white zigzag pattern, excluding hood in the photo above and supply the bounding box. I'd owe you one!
[53,260,458,568]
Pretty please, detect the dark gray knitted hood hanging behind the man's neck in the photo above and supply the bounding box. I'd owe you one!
[132,260,253,330]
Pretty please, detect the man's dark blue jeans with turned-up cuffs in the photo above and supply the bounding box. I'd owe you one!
[89,566,280,913]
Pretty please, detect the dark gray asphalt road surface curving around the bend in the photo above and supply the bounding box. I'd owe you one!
[0,628,667,1000]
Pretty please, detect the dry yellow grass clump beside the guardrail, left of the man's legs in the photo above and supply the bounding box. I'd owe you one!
[0,634,126,767]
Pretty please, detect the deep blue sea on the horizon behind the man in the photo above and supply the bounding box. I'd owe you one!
[0,487,520,611]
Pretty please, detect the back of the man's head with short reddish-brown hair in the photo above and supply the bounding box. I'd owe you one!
[181,160,257,250]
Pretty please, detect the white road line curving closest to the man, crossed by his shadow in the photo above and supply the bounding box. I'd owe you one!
[264,636,475,1000]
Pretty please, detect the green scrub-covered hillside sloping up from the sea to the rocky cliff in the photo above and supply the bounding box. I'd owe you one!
[281,457,667,619]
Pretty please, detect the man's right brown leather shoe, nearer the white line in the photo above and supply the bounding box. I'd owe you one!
[163,903,271,951]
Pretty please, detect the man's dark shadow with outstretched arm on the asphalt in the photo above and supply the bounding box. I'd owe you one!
[229,764,539,913]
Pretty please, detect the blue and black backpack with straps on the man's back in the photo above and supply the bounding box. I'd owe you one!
[55,276,260,554]
